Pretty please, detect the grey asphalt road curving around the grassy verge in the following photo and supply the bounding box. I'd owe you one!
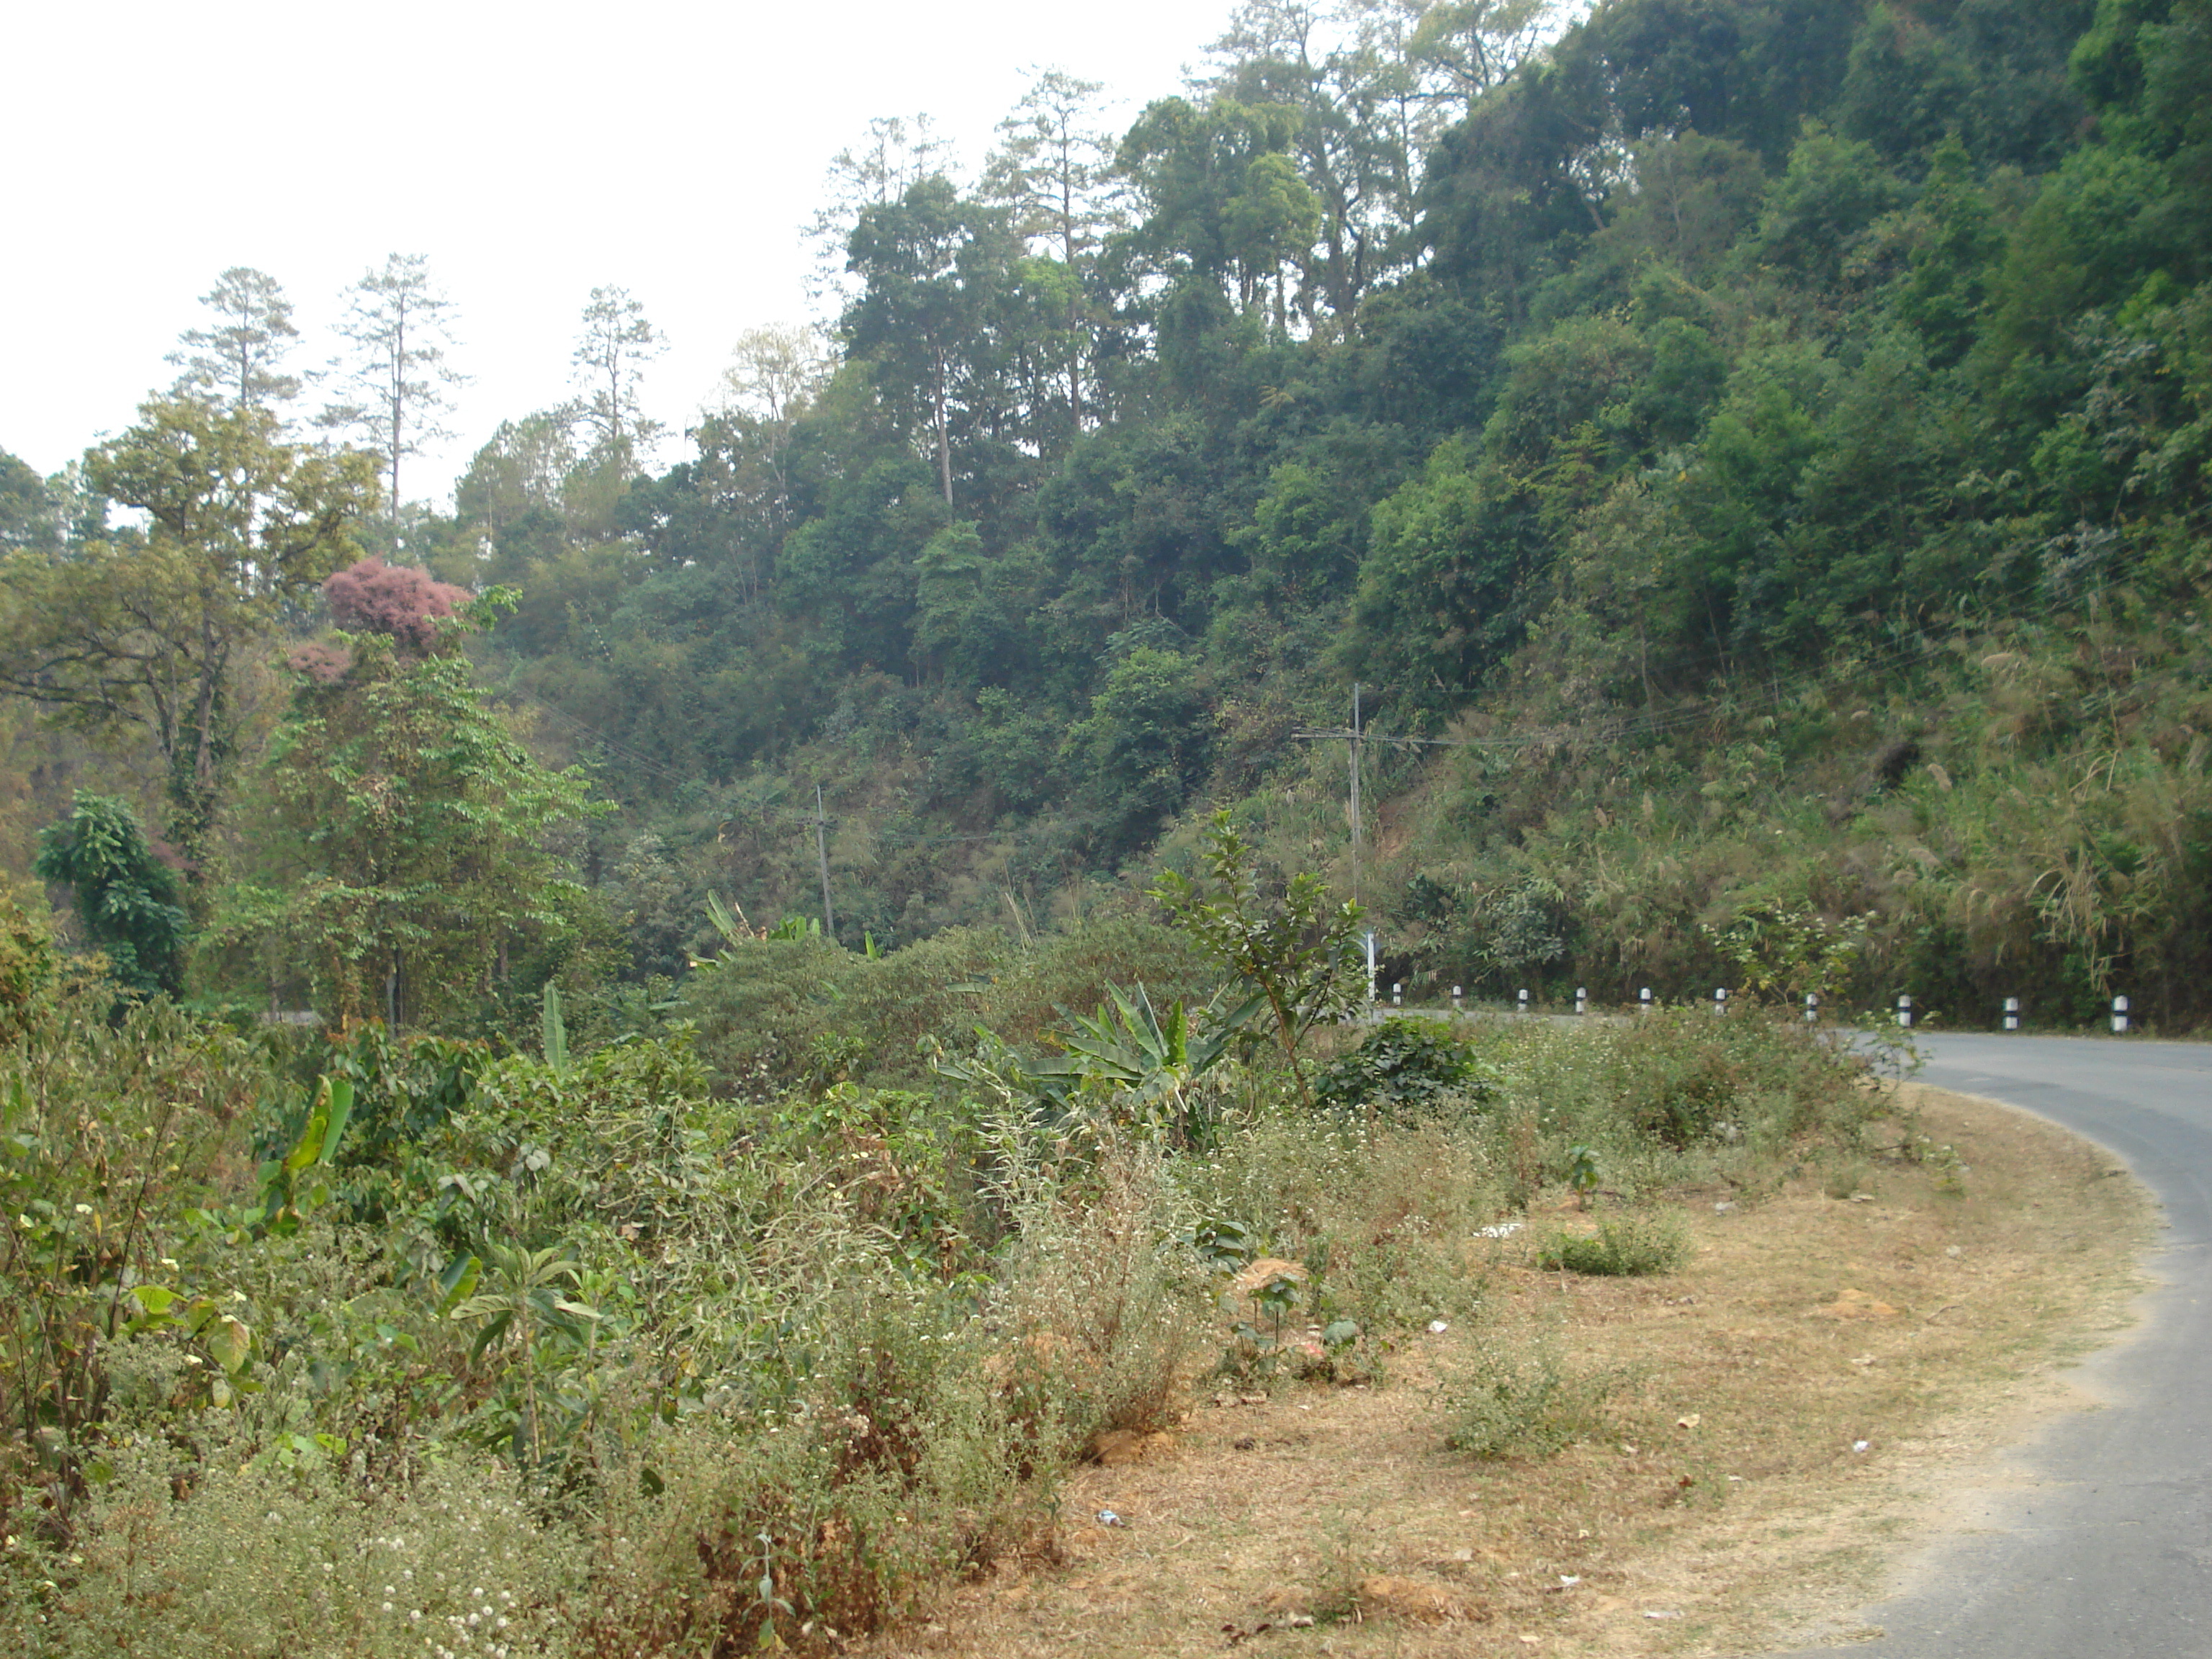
[1778,1035,2212,1659]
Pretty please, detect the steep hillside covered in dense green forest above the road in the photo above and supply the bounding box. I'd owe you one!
[0,0,2212,1028]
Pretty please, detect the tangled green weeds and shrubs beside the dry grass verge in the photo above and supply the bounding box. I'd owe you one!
[0,943,1874,1659]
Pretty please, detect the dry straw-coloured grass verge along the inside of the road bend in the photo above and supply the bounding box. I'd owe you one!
[865,1086,2150,1659]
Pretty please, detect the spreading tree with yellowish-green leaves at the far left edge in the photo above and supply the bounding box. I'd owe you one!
[0,398,376,860]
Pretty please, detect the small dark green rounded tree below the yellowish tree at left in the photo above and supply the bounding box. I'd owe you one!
[31,790,190,995]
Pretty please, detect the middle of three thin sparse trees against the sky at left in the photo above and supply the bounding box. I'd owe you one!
[323,254,462,522]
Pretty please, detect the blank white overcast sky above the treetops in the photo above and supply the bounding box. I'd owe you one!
[0,0,1230,506]
